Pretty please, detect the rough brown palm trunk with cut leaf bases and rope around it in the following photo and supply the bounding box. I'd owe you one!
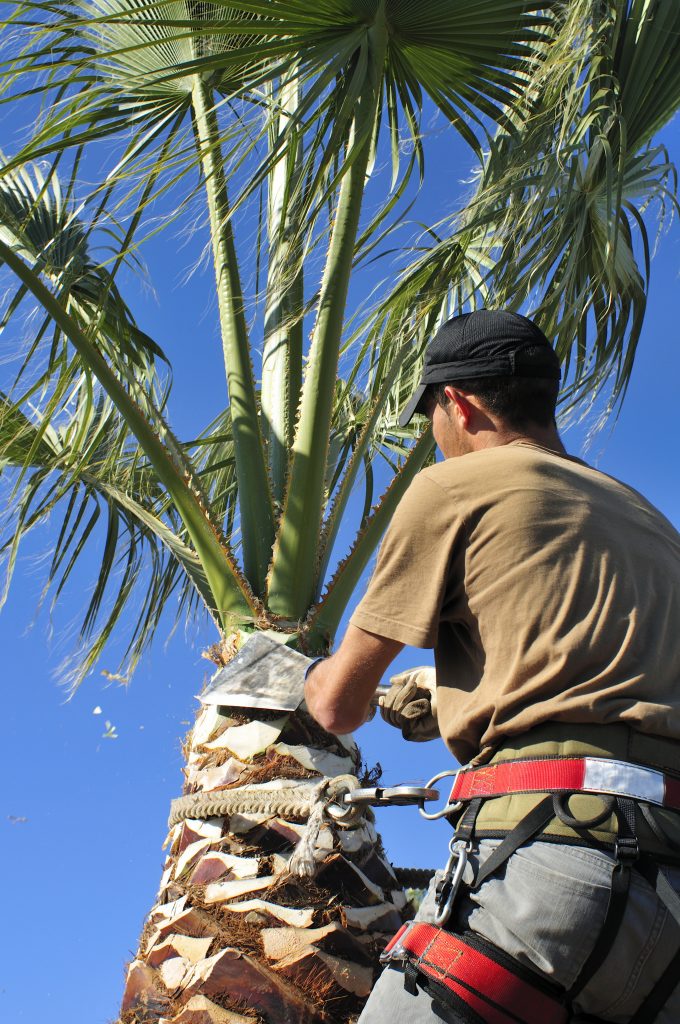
[120,634,407,1024]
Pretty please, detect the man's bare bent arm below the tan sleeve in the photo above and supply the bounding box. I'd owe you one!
[304,624,403,733]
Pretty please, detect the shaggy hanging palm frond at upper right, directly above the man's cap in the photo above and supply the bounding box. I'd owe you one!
[364,0,680,415]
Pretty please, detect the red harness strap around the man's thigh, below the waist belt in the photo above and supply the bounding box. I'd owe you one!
[381,922,567,1024]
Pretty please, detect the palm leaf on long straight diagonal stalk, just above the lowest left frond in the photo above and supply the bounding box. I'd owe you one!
[0,156,262,618]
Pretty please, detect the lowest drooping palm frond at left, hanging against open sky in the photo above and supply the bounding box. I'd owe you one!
[0,385,213,685]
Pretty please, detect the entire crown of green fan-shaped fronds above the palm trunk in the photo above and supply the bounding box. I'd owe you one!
[0,0,680,684]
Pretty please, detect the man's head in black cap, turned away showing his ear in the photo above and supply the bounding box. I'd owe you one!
[399,309,560,457]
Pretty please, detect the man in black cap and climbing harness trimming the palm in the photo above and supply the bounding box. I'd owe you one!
[305,310,680,1024]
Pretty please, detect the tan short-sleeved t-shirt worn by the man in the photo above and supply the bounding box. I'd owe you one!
[351,441,680,762]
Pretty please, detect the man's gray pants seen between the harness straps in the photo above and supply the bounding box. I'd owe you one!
[359,840,680,1024]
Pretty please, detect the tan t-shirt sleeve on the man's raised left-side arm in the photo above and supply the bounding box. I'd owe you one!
[350,473,463,647]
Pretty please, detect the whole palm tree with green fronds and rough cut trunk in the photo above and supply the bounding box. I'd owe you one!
[0,0,680,1024]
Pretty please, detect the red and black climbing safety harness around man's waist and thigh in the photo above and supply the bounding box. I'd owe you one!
[382,757,680,1024]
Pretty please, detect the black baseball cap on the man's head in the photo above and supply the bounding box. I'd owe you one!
[399,309,561,427]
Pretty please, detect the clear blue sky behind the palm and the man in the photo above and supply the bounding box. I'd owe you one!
[0,79,680,1024]
